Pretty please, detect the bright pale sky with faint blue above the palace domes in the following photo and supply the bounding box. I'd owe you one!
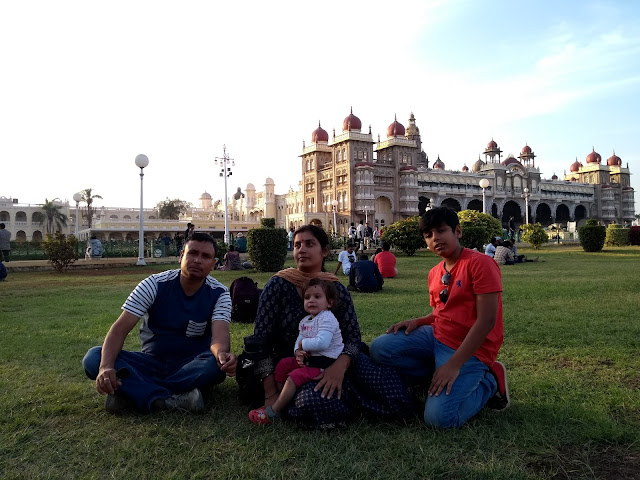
[0,0,640,213]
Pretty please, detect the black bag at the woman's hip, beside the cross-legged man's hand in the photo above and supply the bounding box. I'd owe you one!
[236,335,270,408]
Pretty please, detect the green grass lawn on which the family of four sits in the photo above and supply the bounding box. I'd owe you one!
[0,245,640,479]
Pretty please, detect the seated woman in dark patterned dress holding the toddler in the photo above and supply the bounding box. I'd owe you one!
[254,225,413,428]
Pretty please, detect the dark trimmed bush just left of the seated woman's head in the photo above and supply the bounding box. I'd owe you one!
[247,218,288,272]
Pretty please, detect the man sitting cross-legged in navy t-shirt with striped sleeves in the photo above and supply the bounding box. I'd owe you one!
[82,232,236,413]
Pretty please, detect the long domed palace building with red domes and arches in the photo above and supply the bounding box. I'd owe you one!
[0,110,635,241]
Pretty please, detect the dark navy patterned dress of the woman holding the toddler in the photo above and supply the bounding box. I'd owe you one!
[254,276,413,429]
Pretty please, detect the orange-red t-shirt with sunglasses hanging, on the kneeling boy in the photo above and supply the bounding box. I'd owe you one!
[429,248,504,366]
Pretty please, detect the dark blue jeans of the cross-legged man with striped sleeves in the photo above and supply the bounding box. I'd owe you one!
[82,347,226,412]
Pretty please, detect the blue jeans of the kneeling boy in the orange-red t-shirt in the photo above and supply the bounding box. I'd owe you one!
[370,325,497,428]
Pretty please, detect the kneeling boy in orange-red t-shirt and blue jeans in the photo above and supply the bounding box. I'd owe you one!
[370,207,509,428]
